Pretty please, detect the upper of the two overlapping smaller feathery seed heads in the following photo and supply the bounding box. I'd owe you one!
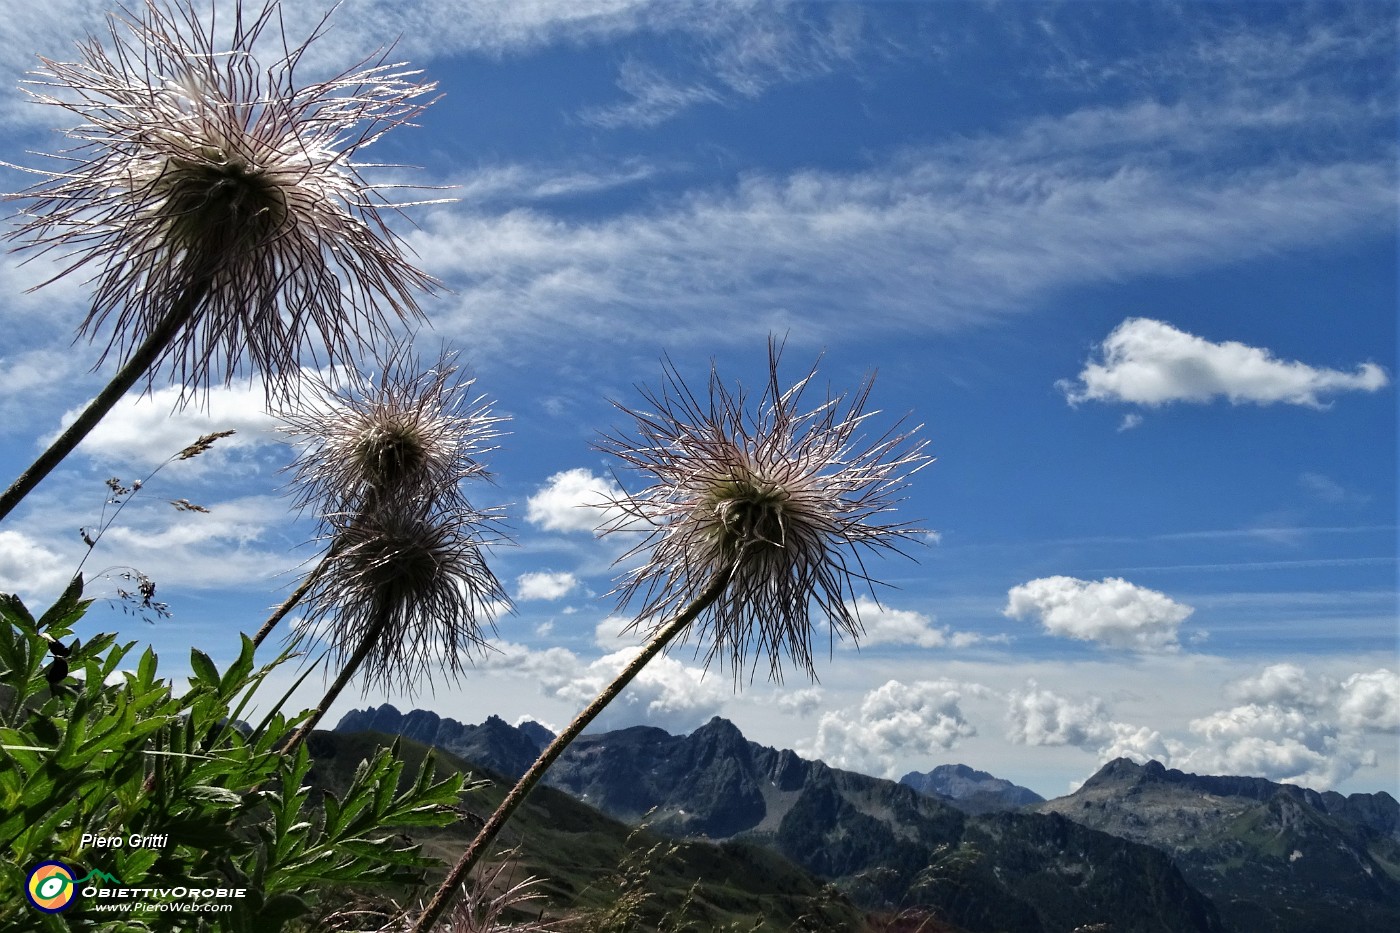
[283,345,505,516]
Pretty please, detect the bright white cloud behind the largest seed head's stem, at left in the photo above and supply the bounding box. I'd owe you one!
[43,382,281,469]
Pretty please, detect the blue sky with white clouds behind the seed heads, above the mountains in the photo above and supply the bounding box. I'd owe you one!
[0,0,1400,796]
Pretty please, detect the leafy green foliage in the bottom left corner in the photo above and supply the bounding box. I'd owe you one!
[0,576,463,933]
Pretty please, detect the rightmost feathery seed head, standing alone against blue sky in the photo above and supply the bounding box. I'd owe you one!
[601,340,931,682]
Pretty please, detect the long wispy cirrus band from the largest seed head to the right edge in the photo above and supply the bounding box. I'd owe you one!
[410,152,1394,348]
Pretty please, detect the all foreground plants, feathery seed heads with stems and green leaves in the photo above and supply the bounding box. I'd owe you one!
[0,0,931,933]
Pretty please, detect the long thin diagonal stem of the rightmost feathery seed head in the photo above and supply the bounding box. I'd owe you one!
[410,567,731,933]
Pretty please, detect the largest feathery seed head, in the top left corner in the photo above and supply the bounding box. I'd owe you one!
[8,0,435,395]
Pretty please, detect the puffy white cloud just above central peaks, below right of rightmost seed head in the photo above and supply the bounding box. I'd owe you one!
[799,681,987,778]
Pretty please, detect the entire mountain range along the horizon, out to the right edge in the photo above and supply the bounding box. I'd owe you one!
[337,706,1400,933]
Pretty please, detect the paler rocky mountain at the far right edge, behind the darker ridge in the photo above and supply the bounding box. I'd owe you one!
[1029,758,1400,933]
